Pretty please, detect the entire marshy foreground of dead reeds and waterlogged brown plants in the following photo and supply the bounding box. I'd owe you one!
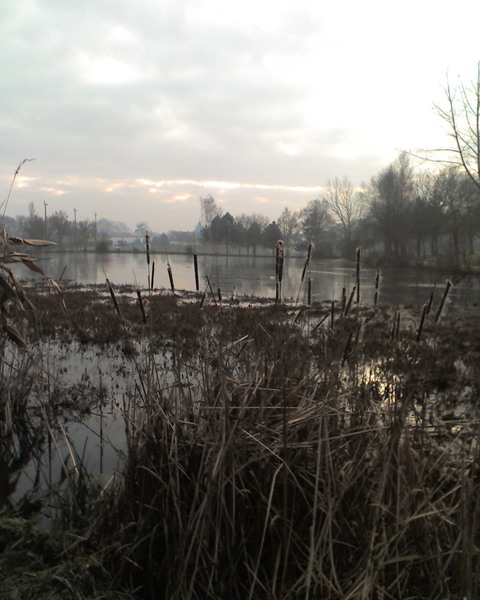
[0,288,480,600]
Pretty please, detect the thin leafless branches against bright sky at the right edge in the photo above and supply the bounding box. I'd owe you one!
[433,63,480,189]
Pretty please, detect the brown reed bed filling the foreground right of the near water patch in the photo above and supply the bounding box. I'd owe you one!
[0,293,480,600]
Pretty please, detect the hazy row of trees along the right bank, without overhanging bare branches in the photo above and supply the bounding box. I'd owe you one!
[201,153,480,264]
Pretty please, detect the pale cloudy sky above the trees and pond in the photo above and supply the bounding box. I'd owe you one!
[0,0,480,232]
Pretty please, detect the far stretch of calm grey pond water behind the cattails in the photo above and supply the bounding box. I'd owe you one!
[27,252,480,308]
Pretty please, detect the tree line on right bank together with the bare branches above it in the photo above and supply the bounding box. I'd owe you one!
[201,63,480,267]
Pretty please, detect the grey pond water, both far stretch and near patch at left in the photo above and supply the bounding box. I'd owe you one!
[7,252,480,516]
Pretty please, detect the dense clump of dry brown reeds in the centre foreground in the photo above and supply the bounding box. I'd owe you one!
[84,298,480,600]
